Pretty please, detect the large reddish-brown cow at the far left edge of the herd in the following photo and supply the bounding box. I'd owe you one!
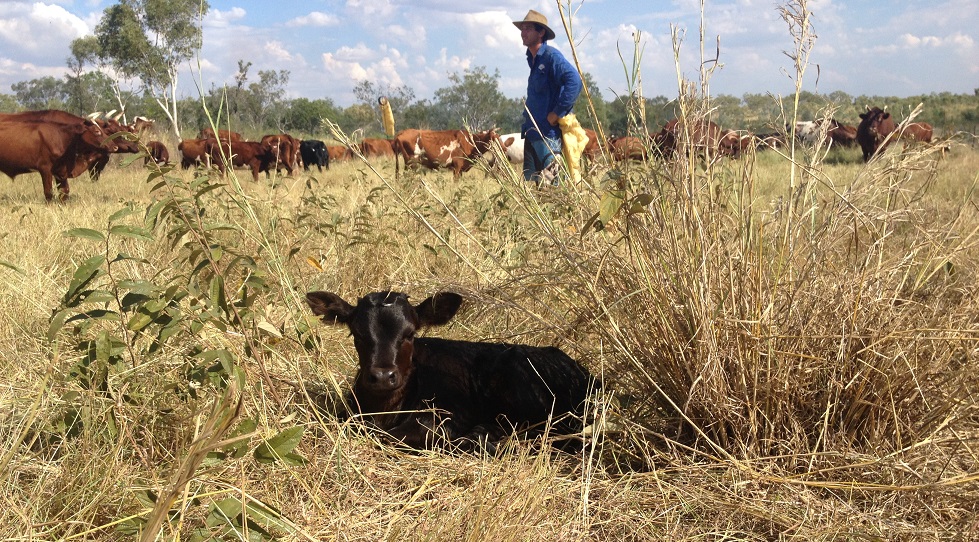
[0,118,118,201]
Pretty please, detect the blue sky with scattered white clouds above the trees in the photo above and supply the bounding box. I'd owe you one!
[0,0,979,106]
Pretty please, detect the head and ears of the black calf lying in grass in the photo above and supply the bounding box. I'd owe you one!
[306,292,462,394]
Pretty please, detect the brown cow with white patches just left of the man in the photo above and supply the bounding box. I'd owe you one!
[393,128,500,179]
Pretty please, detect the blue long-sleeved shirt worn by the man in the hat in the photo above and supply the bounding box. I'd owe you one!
[520,43,581,139]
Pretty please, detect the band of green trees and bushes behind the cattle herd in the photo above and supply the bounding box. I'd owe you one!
[0,65,979,142]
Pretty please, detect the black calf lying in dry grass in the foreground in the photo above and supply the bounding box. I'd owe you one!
[306,292,593,450]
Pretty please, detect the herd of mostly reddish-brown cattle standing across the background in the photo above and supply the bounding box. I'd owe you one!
[0,107,933,201]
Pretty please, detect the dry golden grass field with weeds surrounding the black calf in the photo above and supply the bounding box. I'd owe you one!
[0,130,979,541]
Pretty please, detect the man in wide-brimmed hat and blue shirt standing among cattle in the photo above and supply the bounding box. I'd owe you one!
[513,10,581,186]
